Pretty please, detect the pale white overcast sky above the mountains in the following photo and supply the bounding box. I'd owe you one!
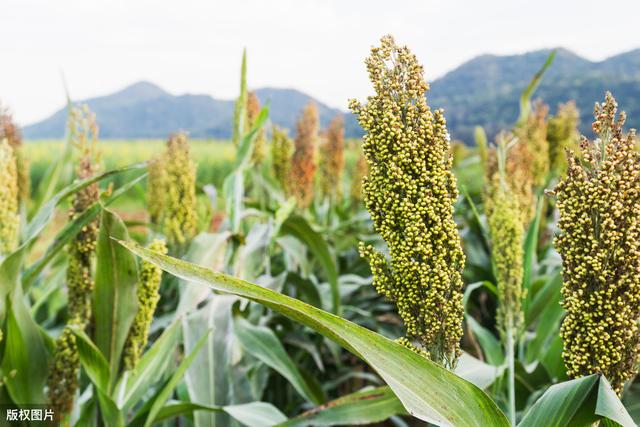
[0,0,640,125]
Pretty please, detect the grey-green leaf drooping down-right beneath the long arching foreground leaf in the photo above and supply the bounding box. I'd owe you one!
[234,316,324,405]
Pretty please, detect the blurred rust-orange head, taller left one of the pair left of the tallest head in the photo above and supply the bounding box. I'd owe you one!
[289,102,318,208]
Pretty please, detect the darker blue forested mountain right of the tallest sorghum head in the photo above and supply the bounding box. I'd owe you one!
[427,48,640,143]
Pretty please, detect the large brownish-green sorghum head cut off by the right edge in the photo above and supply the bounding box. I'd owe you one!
[554,93,640,394]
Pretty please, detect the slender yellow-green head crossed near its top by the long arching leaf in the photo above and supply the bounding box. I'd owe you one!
[124,240,167,369]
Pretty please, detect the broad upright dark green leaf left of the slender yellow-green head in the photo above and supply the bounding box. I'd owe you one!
[93,209,138,392]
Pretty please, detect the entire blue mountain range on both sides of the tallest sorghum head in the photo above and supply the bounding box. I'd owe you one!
[23,48,640,143]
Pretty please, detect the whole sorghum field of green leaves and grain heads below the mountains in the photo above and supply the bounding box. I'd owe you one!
[0,36,640,427]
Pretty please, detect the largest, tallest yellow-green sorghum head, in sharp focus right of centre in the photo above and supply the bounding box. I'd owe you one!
[350,36,465,368]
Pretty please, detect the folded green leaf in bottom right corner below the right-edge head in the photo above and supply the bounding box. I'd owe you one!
[518,375,636,427]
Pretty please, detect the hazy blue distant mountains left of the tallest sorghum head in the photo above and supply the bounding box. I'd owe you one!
[23,82,357,139]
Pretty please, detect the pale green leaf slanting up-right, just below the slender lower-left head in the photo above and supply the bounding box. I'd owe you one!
[115,322,180,411]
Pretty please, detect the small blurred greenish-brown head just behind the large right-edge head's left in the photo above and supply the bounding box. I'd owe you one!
[547,101,580,175]
